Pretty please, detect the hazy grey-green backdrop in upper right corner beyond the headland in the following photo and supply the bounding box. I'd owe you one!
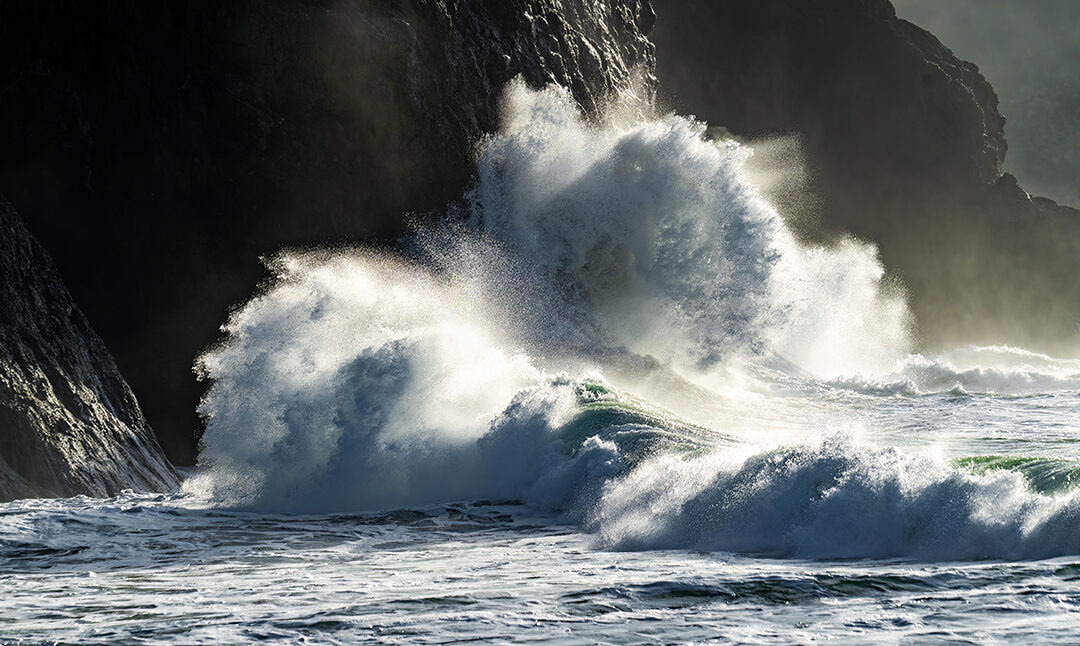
[893,0,1080,207]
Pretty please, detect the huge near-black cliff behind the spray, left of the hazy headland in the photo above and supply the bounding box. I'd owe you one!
[0,0,654,463]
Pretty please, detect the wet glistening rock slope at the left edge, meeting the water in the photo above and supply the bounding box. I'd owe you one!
[0,200,179,500]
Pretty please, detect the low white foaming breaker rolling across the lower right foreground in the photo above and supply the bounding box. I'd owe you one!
[592,436,1080,560]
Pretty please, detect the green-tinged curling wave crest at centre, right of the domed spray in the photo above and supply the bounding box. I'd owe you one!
[558,381,726,467]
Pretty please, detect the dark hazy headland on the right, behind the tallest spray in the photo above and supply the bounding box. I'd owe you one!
[653,0,1080,353]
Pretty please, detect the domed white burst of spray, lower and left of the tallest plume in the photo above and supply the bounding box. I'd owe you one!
[191,254,609,511]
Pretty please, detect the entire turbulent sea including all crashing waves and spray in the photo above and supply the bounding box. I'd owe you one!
[0,84,1080,644]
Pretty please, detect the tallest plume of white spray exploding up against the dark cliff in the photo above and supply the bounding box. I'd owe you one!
[416,83,910,375]
